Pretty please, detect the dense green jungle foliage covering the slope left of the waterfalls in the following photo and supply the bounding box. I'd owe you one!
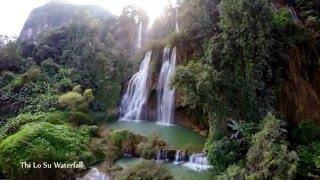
[0,3,138,179]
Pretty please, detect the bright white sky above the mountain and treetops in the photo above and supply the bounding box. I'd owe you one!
[0,0,174,36]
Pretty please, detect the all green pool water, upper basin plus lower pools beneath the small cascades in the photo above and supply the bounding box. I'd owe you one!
[107,121,213,180]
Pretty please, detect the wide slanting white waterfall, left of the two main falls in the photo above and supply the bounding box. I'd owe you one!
[120,51,152,120]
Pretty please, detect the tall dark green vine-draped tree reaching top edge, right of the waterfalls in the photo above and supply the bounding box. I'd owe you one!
[209,0,273,121]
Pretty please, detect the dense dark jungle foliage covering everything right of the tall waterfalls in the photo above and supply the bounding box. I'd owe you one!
[171,0,320,179]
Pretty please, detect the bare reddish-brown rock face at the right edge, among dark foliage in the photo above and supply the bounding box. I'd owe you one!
[280,48,320,124]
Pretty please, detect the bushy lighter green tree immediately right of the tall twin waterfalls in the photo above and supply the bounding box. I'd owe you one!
[173,61,220,116]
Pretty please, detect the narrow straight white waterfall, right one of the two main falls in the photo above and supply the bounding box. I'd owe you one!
[157,47,177,125]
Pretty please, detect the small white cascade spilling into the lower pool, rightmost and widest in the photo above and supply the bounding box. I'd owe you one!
[184,153,212,171]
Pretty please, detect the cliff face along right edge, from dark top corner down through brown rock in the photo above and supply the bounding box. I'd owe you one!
[276,0,320,124]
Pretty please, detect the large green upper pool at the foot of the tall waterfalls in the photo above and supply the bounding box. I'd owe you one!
[107,121,205,149]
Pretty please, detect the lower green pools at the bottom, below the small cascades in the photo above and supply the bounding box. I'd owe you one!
[116,157,214,180]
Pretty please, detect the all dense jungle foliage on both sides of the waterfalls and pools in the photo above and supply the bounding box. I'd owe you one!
[0,0,320,179]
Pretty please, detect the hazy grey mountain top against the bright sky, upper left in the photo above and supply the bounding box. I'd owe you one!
[19,2,112,41]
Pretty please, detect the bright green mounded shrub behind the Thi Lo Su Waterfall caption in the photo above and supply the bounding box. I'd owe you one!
[0,122,90,179]
